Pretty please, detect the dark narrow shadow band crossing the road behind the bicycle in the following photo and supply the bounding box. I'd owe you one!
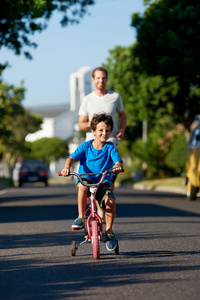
[0,203,200,223]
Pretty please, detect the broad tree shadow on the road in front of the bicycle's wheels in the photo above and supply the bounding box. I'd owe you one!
[1,252,200,300]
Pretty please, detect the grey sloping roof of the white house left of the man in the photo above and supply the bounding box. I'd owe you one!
[27,104,70,118]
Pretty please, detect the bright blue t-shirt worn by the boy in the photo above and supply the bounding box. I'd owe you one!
[70,140,122,183]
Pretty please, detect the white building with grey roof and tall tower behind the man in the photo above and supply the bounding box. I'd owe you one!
[22,67,93,176]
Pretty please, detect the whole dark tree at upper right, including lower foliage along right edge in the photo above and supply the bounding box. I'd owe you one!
[132,0,200,128]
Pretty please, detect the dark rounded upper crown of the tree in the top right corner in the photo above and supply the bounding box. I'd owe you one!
[132,0,200,85]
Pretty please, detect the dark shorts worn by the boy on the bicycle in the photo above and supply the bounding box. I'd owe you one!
[77,177,115,209]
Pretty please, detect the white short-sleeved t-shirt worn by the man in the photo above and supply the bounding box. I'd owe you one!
[79,90,124,144]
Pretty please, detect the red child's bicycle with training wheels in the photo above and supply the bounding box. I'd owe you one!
[58,168,119,259]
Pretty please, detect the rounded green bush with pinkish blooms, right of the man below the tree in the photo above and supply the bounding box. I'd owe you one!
[118,115,187,178]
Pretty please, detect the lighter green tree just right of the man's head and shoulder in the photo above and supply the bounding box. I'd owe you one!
[103,44,179,127]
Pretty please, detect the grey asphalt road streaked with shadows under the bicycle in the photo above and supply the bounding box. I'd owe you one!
[0,183,200,300]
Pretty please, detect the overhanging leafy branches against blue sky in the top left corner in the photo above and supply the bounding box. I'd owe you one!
[0,0,95,59]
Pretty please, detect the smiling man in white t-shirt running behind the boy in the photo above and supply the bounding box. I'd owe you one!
[78,67,126,217]
